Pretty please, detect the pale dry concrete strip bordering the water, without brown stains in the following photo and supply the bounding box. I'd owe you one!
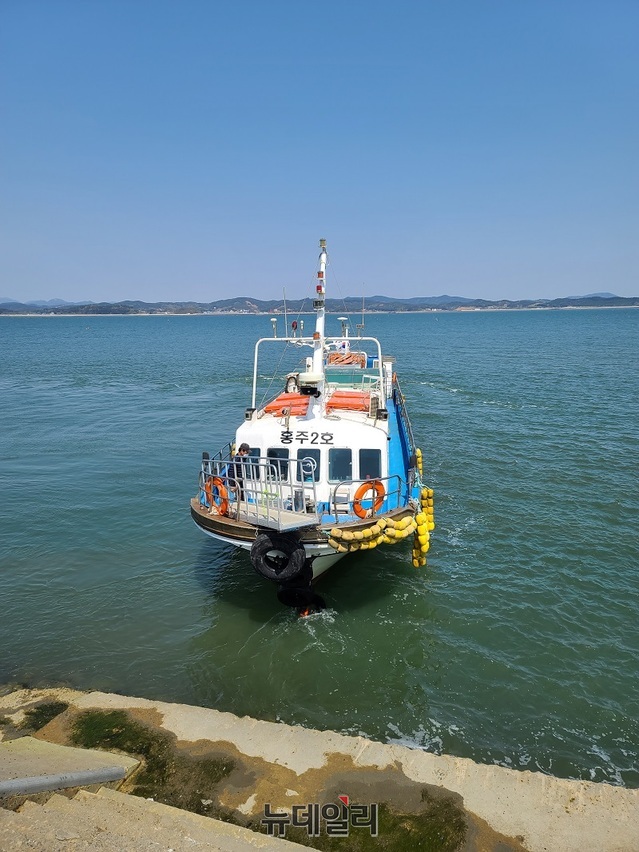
[0,689,639,852]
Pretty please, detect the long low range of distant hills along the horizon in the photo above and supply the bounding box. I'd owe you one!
[0,293,639,315]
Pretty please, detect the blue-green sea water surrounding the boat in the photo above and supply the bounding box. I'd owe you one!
[0,309,639,787]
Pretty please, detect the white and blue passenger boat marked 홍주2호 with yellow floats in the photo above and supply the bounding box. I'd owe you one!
[191,240,435,614]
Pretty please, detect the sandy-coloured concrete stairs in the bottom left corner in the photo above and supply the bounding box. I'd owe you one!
[0,788,306,852]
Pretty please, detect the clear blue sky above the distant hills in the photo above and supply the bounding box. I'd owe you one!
[0,0,639,301]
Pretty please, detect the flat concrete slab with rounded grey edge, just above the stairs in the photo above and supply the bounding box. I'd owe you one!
[0,737,139,799]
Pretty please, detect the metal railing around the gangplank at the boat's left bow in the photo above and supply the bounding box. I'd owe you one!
[199,454,320,532]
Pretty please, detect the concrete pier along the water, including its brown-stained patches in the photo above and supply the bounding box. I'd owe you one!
[0,689,639,852]
